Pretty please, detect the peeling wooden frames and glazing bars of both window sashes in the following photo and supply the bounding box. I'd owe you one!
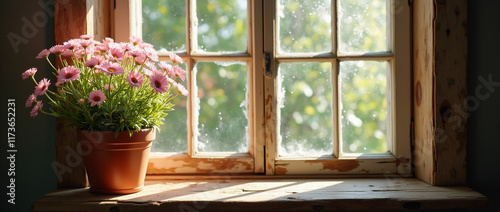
[113,0,411,175]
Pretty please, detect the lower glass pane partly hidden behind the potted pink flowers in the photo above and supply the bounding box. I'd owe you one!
[151,63,188,153]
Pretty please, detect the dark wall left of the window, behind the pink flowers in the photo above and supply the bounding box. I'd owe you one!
[0,0,57,211]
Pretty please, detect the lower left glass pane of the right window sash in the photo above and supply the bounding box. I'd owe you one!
[278,62,333,156]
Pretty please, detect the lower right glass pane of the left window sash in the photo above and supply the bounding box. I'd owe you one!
[195,62,248,152]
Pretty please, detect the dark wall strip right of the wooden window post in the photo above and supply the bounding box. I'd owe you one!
[467,0,500,211]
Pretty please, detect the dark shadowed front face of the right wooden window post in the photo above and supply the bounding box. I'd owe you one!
[434,0,468,185]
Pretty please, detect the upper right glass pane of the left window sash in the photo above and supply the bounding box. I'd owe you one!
[196,0,248,52]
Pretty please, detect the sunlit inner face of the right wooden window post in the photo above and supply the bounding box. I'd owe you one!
[413,0,435,184]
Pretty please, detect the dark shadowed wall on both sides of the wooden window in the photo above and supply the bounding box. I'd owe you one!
[0,0,500,211]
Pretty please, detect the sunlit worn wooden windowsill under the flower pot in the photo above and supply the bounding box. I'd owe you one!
[33,178,488,211]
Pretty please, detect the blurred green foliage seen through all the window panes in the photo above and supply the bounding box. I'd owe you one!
[142,0,390,155]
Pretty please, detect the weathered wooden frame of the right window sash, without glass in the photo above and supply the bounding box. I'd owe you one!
[264,0,411,177]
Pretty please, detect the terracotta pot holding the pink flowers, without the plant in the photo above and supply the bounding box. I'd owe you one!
[77,129,156,194]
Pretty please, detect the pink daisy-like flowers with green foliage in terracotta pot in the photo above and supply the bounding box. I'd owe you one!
[22,35,188,194]
